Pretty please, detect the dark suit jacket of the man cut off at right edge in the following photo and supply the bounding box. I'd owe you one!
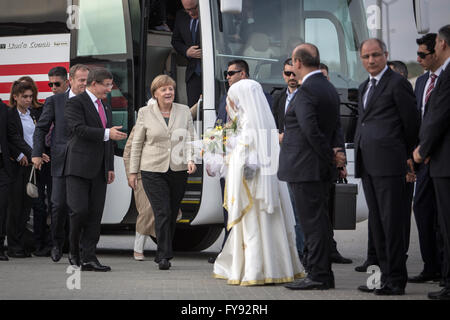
[419,66,450,178]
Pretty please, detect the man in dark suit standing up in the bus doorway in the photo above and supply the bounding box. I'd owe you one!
[172,0,202,107]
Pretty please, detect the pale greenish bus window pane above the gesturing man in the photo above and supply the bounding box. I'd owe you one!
[77,0,127,56]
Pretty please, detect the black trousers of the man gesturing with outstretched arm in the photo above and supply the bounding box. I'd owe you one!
[66,170,106,262]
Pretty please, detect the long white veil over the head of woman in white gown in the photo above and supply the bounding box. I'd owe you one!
[228,79,280,213]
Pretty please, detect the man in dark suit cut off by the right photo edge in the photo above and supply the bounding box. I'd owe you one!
[414,25,450,300]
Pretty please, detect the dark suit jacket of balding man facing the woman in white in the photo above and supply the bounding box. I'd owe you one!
[278,74,340,182]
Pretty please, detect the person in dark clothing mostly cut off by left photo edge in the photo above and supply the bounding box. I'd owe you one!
[0,99,13,261]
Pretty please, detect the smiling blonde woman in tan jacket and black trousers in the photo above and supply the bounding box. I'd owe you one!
[128,75,197,270]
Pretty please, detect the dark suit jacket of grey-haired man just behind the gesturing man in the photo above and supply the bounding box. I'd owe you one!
[32,92,69,177]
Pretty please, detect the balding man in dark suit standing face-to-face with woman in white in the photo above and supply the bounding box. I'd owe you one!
[278,43,340,290]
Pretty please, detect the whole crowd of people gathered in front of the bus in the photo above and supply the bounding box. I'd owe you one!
[0,0,450,299]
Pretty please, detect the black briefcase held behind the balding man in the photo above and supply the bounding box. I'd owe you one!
[330,179,358,230]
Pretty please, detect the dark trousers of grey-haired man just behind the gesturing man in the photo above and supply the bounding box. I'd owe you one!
[51,176,69,248]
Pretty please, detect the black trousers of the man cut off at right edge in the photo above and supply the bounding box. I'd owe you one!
[433,178,450,289]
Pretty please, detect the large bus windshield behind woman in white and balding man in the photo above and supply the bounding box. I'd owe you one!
[212,0,368,90]
